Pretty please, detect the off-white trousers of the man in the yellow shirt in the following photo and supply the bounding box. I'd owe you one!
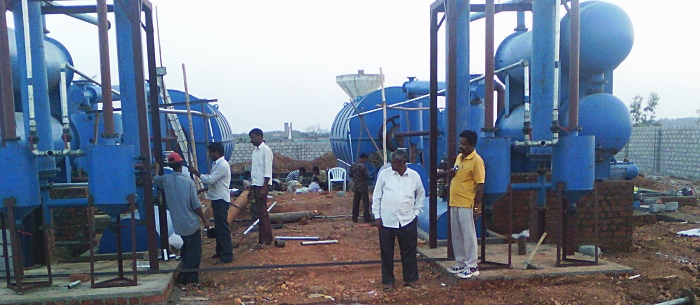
[450,207,479,268]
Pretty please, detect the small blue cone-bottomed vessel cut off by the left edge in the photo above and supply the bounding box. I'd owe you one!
[0,146,41,220]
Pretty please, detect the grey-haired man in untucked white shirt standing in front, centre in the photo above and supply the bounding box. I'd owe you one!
[372,150,425,291]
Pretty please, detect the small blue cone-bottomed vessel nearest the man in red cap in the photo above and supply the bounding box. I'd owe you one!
[88,145,136,218]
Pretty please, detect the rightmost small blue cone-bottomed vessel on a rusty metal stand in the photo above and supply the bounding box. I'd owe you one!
[552,136,595,207]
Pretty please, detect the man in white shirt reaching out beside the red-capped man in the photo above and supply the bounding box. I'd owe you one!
[188,142,233,264]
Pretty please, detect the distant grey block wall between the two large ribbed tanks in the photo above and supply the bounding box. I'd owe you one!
[229,139,332,163]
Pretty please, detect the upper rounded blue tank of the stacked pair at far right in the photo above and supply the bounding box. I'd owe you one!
[560,1,634,73]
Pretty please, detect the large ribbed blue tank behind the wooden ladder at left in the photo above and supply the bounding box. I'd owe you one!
[167,90,234,174]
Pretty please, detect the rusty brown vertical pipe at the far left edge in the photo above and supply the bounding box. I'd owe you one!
[0,0,19,141]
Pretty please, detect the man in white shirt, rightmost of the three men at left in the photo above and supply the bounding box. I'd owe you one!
[248,128,272,249]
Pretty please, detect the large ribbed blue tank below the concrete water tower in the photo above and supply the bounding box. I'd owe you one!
[330,87,428,173]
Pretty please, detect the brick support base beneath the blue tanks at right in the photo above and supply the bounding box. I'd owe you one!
[493,173,635,252]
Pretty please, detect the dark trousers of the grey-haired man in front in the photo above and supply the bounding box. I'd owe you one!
[379,218,418,284]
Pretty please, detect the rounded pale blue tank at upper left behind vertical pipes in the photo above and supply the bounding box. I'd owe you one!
[8,28,73,97]
